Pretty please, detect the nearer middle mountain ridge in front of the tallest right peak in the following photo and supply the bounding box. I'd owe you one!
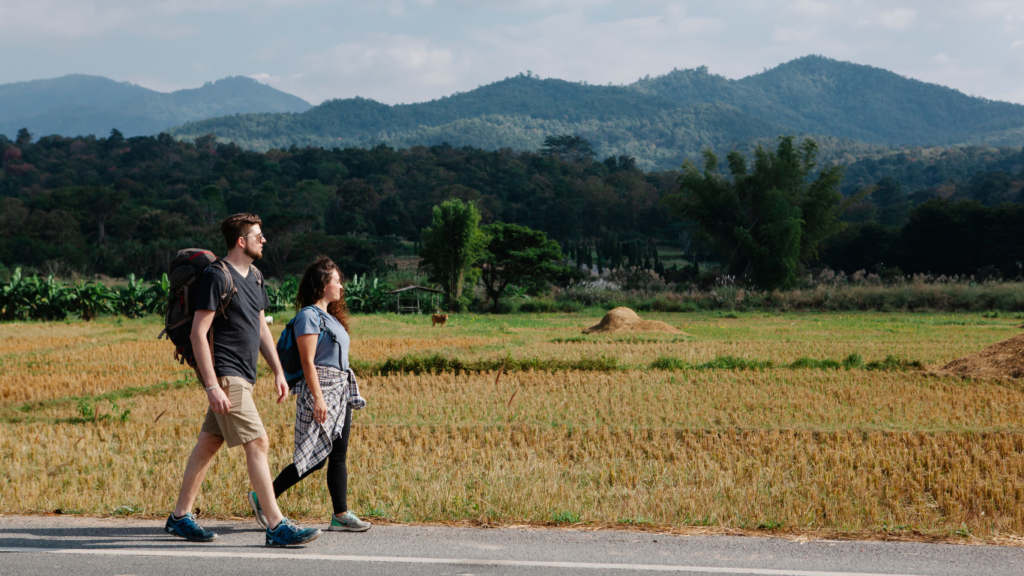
[169,76,802,168]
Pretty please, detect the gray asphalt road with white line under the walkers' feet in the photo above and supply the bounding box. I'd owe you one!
[0,516,1024,576]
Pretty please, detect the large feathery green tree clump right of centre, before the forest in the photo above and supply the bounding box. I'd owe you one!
[664,136,843,288]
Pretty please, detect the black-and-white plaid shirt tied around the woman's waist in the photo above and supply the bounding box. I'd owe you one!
[292,366,367,476]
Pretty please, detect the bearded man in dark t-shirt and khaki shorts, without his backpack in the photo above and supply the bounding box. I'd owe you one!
[165,213,321,546]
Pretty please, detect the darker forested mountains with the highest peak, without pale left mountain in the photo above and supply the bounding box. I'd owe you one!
[157,56,1024,168]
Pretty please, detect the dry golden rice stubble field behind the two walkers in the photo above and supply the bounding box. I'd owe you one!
[0,314,1024,541]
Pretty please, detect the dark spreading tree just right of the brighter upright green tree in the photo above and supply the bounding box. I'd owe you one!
[480,222,562,312]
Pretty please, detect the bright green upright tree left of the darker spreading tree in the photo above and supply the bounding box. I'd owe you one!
[420,198,487,310]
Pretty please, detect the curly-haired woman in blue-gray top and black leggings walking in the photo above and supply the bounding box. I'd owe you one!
[249,256,370,532]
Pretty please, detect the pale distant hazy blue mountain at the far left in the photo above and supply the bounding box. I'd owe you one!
[0,75,310,136]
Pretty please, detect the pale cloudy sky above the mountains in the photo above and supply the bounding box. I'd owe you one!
[0,0,1024,104]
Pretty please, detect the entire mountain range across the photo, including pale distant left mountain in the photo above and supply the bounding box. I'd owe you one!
[0,55,1024,169]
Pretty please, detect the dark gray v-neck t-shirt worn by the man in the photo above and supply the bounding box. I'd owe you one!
[196,263,270,383]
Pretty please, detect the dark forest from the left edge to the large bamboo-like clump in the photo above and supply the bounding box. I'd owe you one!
[0,130,686,279]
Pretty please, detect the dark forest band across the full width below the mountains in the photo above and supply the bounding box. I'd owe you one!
[0,124,1024,286]
